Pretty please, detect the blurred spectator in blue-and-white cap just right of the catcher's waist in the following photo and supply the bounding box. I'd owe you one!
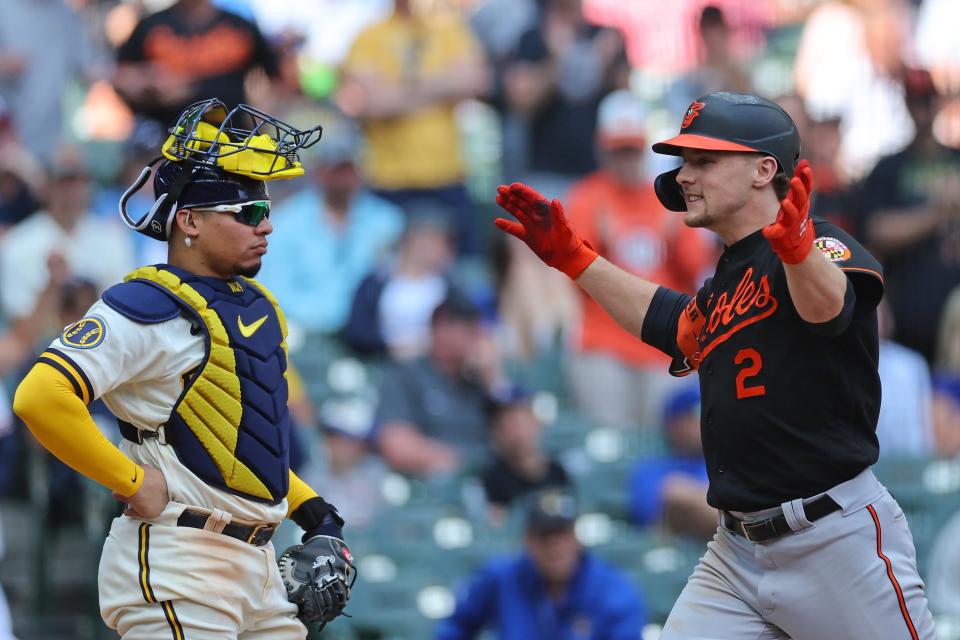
[301,398,387,529]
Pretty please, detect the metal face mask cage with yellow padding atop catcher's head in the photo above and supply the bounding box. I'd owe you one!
[165,98,323,177]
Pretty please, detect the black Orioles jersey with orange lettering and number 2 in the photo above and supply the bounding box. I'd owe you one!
[642,221,883,511]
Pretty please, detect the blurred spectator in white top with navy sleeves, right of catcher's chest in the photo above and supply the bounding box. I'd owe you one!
[343,213,454,360]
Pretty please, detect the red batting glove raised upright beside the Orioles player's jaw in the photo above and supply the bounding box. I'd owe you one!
[763,160,815,264]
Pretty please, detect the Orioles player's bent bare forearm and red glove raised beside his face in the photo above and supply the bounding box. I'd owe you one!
[763,160,853,324]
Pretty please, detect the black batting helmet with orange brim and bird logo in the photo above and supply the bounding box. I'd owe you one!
[653,92,800,211]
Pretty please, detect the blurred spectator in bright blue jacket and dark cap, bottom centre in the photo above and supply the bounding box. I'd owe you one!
[434,489,646,640]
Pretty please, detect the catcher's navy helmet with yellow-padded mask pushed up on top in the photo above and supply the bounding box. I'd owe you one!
[120,99,322,240]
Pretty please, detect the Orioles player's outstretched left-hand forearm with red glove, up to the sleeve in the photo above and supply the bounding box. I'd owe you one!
[495,182,658,338]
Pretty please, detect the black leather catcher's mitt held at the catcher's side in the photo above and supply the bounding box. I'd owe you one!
[277,536,356,629]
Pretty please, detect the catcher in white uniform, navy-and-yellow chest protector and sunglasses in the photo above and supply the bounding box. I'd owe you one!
[14,100,353,640]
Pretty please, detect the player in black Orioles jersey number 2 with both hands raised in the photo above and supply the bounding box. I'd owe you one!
[496,93,934,640]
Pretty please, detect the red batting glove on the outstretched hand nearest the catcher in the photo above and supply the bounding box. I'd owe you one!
[494,182,597,279]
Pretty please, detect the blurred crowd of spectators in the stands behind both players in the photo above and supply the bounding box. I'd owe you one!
[0,0,960,638]
